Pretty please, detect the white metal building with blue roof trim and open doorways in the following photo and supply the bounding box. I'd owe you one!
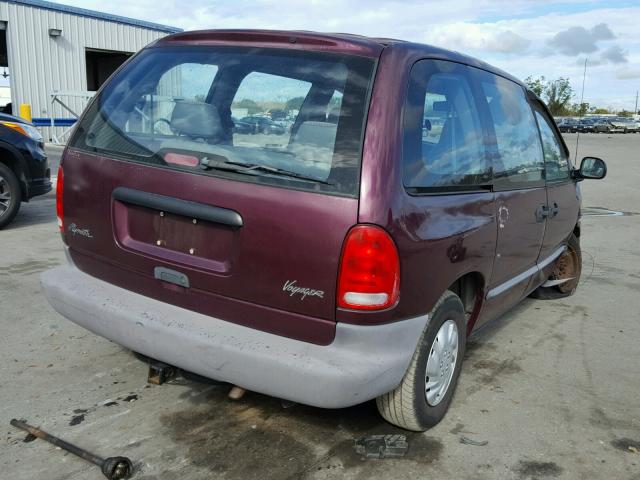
[0,0,181,141]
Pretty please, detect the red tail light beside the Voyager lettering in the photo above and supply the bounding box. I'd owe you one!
[337,225,400,310]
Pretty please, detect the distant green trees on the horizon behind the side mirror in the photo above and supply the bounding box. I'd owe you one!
[524,76,640,117]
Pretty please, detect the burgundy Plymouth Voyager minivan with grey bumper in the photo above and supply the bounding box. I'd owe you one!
[42,30,606,430]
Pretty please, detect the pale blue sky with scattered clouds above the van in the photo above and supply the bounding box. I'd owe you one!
[60,0,640,109]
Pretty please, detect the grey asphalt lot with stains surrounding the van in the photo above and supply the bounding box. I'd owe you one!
[0,134,640,480]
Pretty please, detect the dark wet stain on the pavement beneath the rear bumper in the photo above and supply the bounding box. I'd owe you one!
[145,374,443,480]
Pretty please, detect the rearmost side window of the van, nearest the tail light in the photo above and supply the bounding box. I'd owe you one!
[403,60,491,192]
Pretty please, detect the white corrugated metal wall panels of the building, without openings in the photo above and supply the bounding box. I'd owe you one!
[0,1,167,140]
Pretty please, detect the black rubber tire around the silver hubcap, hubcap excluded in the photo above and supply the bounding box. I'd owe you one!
[376,291,467,432]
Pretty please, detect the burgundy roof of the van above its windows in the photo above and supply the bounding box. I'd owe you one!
[154,29,524,86]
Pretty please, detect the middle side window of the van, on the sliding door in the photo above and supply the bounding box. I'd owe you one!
[481,74,544,189]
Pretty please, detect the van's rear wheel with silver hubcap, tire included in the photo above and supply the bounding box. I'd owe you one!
[376,291,466,432]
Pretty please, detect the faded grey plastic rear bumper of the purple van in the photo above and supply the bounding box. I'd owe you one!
[40,265,428,408]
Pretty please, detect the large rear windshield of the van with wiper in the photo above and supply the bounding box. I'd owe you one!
[70,47,374,196]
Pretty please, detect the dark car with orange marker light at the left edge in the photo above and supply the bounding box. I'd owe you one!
[0,113,51,229]
